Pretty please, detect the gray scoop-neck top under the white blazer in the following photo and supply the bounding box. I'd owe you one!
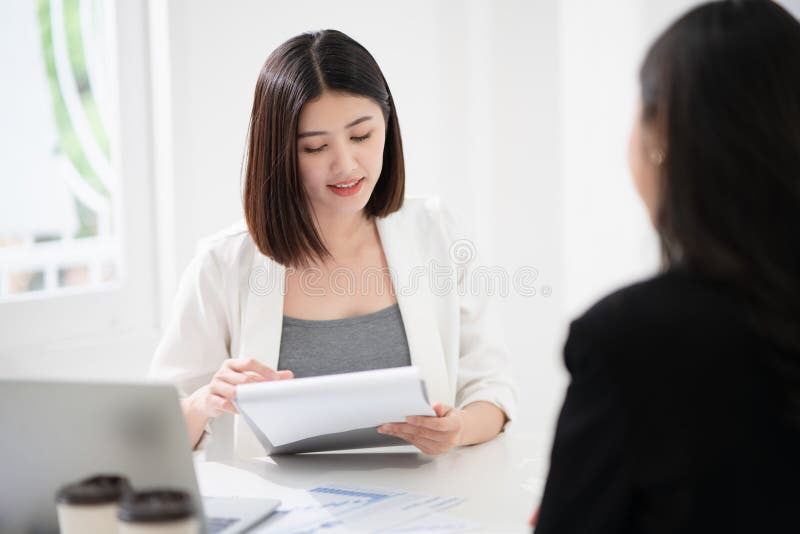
[278,304,411,378]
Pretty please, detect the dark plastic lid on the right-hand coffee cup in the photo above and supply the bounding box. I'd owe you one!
[117,489,194,523]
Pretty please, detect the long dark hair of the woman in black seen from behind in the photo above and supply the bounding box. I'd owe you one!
[640,0,800,354]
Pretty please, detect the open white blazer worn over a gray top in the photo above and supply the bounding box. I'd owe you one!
[150,198,516,459]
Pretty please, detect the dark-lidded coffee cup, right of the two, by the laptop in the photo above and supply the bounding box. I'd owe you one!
[117,489,200,534]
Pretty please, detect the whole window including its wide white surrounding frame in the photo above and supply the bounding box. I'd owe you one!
[0,0,158,364]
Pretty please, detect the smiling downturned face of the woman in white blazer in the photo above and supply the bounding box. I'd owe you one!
[297,91,386,220]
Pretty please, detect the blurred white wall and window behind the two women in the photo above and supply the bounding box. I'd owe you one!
[0,0,800,456]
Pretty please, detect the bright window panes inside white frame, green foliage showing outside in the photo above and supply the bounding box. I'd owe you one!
[0,0,121,301]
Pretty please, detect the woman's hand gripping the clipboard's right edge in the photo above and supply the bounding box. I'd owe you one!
[378,403,464,454]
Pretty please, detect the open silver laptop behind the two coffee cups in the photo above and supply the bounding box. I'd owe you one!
[0,380,280,534]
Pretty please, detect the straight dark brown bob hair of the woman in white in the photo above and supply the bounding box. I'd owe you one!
[243,30,405,266]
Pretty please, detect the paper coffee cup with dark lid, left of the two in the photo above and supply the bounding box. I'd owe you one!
[56,475,130,534]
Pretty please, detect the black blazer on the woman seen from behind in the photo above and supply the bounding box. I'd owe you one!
[535,269,800,534]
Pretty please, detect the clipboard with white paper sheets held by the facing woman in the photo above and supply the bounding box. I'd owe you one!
[234,366,436,454]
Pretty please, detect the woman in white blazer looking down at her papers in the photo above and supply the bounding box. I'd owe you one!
[150,30,515,457]
